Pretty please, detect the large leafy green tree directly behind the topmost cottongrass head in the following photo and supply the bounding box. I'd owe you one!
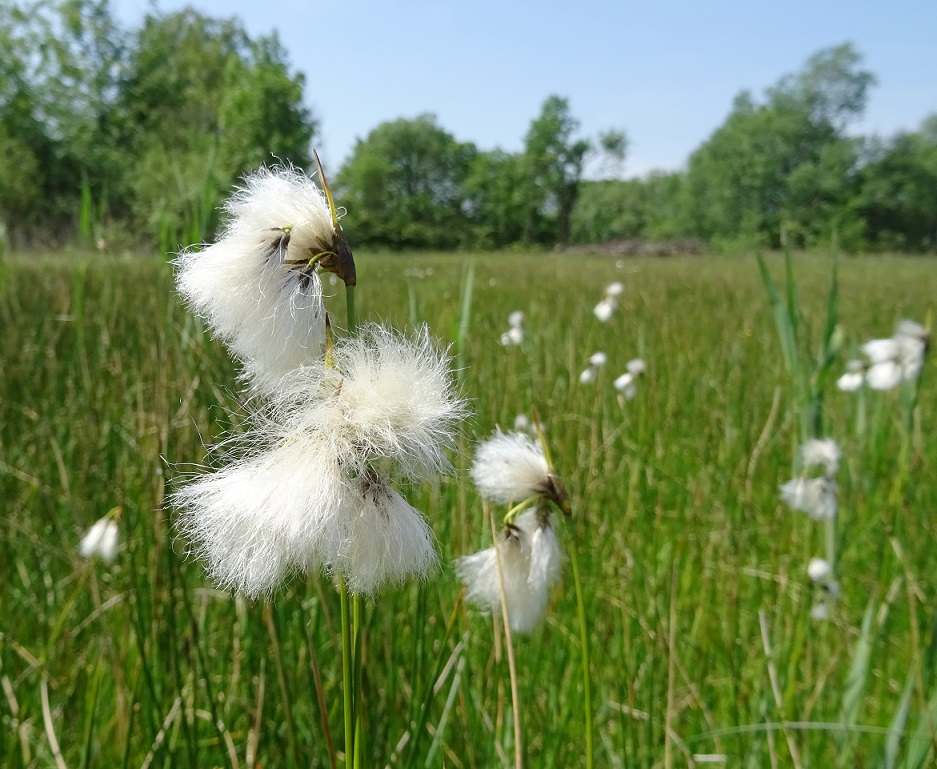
[119,9,316,248]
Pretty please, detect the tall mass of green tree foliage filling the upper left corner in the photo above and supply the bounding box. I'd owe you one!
[0,0,316,248]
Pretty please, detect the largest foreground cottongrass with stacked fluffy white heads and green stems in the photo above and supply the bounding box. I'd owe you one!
[170,157,466,767]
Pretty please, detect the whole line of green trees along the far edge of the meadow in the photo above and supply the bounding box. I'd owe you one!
[0,0,937,252]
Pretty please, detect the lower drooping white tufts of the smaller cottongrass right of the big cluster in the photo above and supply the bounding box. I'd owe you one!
[455,509,563,633]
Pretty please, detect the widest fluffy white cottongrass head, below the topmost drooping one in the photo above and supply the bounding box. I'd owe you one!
[171,326,465,597]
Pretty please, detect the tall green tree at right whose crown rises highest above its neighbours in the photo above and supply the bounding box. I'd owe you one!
[686,44,874,245]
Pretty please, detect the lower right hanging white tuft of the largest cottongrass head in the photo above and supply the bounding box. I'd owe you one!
[338,474,436,595]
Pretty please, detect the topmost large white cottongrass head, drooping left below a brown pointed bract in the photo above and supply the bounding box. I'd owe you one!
[174,166,333,390]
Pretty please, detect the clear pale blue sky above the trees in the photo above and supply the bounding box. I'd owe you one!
[111,0,937,176]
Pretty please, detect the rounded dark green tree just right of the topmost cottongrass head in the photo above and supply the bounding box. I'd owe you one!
[335,114,477,248]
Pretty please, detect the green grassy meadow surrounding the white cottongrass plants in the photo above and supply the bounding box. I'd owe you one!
[0,253,937,769]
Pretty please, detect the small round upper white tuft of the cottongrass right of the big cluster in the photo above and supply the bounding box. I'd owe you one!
[471,430,550,504]
